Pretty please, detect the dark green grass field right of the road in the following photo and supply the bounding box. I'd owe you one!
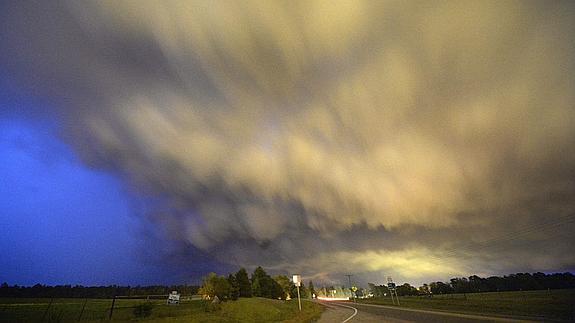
[360,289,575,320]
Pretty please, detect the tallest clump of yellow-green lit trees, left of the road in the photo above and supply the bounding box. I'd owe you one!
[198,267,315,300]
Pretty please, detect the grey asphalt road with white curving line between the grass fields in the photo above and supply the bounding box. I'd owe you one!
[318,301,530,323]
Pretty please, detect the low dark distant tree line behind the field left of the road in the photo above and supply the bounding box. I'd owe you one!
[0,283,199,298]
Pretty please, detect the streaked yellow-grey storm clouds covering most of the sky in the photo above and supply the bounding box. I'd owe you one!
[0,0,575,283]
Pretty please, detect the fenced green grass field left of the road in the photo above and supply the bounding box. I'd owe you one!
[0,298,323,322]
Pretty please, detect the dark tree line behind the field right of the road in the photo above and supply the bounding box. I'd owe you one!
[369,272,575,297]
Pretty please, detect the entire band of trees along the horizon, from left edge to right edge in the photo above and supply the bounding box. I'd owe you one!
[4,267,575,300]
